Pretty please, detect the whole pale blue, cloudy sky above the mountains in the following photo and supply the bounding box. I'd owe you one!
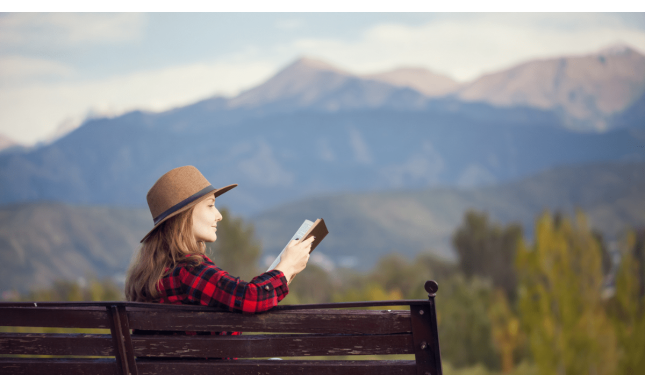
[0,12,645,146]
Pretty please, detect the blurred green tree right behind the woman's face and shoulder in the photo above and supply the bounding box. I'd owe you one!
[206,208,262,281]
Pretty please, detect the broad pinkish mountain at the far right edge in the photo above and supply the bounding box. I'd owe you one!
[456,46,645,130]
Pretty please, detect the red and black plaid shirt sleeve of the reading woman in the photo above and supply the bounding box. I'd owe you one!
[177,264,289,314]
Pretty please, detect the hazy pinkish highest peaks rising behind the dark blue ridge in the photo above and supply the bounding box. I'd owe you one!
[185,45,645,131]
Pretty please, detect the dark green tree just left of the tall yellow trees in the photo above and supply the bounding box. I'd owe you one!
[452,210,522,299]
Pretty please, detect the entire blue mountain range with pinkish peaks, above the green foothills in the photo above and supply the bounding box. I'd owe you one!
[0,47,645,216]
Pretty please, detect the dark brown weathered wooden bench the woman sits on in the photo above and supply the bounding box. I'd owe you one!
[0,281,442,375]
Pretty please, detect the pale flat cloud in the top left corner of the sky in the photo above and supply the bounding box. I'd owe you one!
[0,13,146,48]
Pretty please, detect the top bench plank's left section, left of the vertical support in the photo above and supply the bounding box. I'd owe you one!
[0,307,110,329]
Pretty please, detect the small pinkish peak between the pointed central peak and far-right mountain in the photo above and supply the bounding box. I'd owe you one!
[363,67,459,97]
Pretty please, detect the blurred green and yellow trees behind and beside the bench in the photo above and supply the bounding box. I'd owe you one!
[0,209,645,374]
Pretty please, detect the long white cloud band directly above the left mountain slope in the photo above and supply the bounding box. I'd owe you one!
[0,61,275,144]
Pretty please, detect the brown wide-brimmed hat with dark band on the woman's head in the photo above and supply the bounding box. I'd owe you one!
[141,165,237,243]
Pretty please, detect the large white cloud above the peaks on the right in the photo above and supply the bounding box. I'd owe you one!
[292,14,645,81]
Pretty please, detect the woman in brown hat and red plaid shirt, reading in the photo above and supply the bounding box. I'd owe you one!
[125,166,313,320]
